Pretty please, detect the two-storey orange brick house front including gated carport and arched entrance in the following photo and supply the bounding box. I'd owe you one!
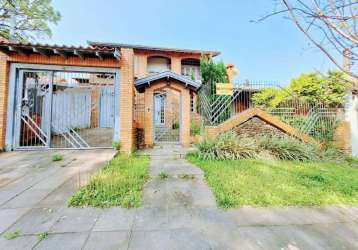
[0,41,219,152]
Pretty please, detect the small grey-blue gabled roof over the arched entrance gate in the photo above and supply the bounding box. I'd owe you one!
[135,71,201,90]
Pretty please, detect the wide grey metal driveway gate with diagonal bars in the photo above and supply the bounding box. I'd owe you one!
[13,67,118,149]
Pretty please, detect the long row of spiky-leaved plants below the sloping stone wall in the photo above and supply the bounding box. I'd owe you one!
[195,132,352,165]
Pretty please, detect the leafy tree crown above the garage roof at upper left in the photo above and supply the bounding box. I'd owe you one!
[0,0,61,42]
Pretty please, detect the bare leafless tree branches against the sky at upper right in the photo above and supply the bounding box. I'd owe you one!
[259,0,358,83]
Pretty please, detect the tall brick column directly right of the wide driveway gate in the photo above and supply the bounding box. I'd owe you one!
[119,48,134,153]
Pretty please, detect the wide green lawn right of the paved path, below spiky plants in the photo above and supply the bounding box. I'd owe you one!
[187,155,358,208]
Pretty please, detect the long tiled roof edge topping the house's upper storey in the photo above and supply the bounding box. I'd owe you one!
[88,41,220,57]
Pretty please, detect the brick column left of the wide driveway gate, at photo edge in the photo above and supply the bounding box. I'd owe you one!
[0,52,9,150]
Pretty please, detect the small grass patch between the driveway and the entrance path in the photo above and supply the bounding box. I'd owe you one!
[69,155,149,208]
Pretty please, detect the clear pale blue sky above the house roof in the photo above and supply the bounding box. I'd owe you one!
[43,0,332,85]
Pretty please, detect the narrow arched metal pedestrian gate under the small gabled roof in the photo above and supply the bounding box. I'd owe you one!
[153,88,181,143]
